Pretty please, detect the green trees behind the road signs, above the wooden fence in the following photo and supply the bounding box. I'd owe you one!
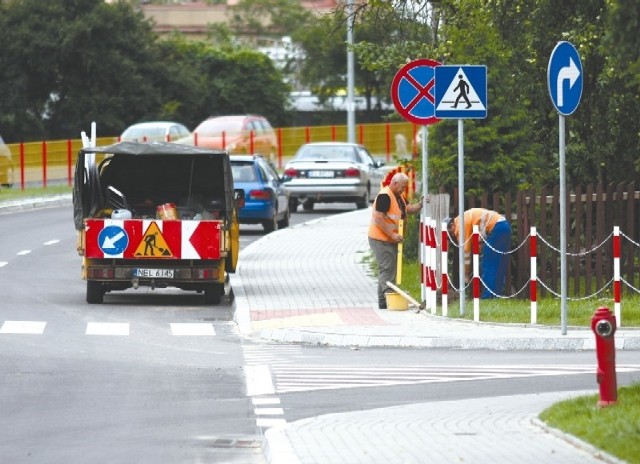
[342,0,640,194]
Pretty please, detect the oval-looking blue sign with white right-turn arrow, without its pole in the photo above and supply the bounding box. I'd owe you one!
[547,42,582,116]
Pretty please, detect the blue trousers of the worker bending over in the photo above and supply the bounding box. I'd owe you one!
[480,221,511,298]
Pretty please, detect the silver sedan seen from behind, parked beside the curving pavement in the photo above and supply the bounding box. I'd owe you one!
[284,142,388,211]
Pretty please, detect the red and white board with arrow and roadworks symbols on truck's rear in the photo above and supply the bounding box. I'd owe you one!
[85,219,222,259]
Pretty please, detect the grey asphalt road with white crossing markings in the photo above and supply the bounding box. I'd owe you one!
[0,205,640,464]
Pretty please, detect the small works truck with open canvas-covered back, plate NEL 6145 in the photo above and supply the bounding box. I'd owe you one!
[73,142,244,305]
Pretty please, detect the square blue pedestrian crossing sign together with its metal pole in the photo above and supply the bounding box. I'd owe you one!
[435,65,487,316]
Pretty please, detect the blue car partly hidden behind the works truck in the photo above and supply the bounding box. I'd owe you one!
[231,155,290,232]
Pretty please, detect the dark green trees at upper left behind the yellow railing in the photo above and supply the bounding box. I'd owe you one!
[0,0,289,142]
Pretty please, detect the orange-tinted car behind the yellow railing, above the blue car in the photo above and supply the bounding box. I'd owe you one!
[180,114,278,163]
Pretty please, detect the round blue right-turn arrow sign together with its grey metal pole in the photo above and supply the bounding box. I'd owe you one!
[547,42,582,335]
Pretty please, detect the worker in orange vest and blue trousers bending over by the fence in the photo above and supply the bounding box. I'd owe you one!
[446,208,511,298]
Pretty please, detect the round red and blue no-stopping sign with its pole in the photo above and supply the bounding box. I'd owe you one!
[391,58,440,301]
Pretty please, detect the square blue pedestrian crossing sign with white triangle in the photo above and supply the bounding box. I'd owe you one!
[435,65,487,119]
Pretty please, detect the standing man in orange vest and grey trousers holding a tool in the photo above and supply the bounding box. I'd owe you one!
[369,172,422,309]
